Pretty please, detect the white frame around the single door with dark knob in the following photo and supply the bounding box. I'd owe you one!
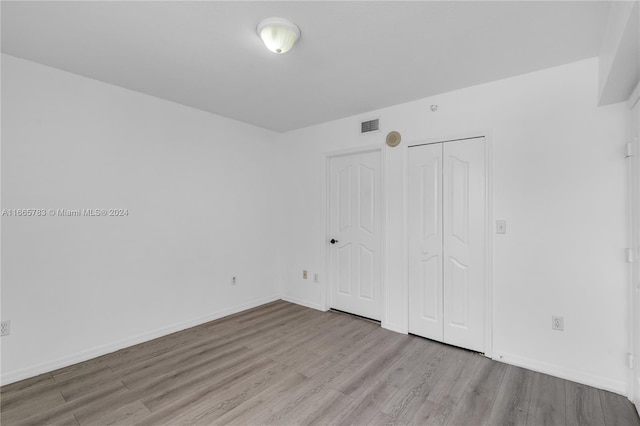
[321,145,387,327]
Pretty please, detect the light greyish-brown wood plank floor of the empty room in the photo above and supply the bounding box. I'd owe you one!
[0,301,640,426]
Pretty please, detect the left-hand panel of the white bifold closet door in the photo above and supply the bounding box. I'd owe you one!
[408,144,443,341]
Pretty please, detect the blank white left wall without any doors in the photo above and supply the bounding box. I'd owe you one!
[1,55,281,383]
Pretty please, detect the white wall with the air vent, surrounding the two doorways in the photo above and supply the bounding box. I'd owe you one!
[281,59,629,393]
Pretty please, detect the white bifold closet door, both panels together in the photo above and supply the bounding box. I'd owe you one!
[408,138,486,352]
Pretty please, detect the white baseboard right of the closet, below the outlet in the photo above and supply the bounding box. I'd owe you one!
[493,352,627,396]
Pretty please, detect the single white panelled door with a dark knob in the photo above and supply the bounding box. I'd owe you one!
[328,151,382,320]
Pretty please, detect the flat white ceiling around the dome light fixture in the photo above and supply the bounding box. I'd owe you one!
[1,1,609,132]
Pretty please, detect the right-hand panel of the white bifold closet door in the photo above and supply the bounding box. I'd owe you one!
[443,139,486,352]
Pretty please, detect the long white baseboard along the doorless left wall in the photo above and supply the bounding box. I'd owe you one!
[0,295,280,386]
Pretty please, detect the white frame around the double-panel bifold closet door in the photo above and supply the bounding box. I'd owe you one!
[404,130,494,358]
